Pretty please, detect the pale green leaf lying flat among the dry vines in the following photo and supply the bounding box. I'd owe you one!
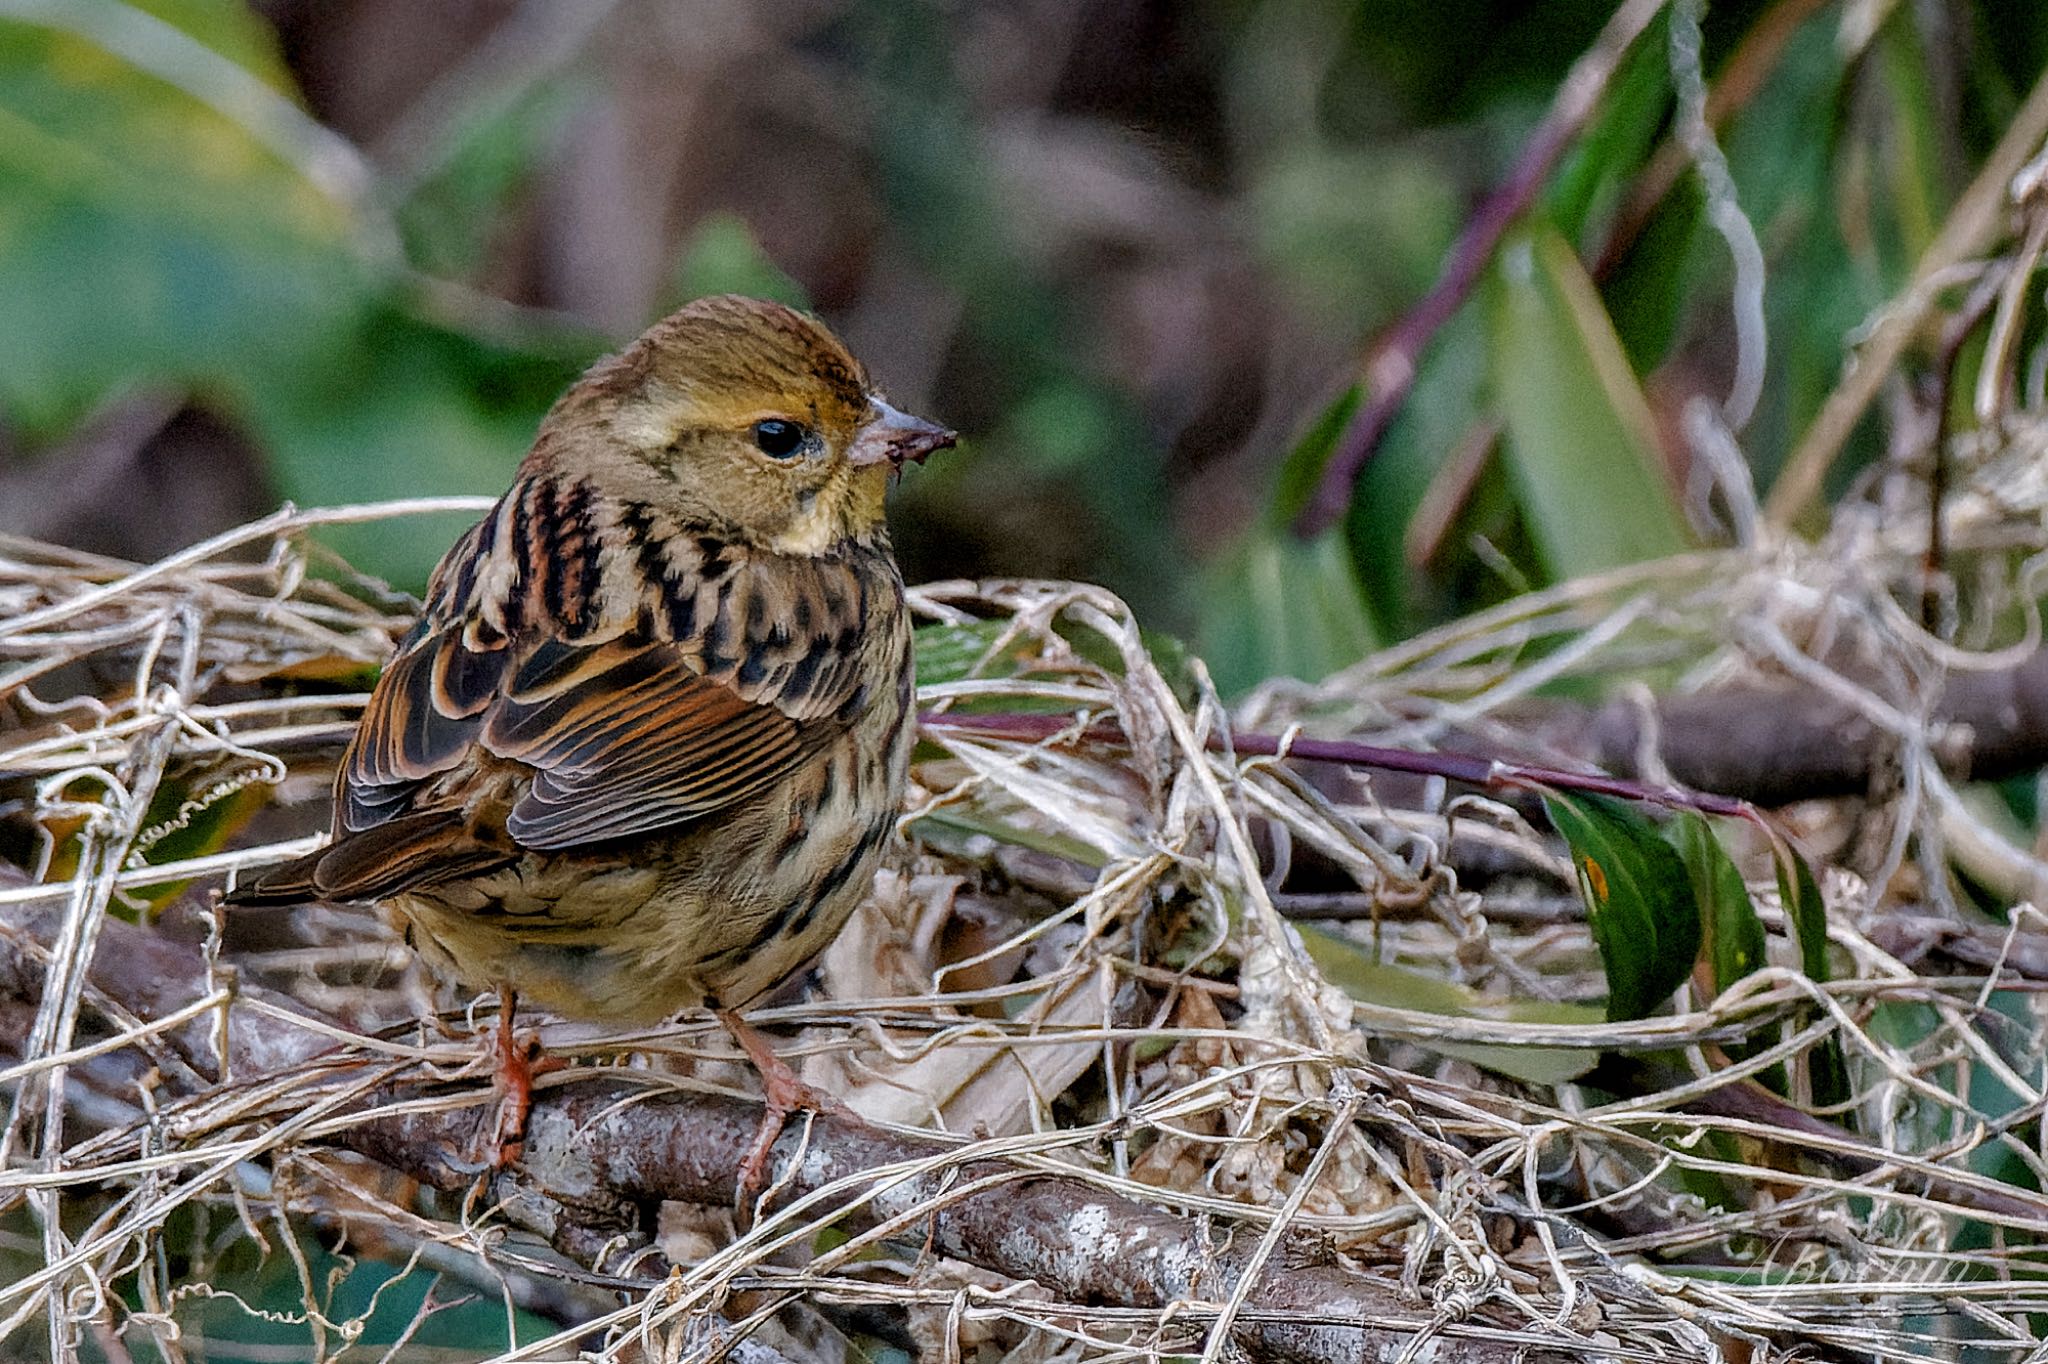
[1296,924,1599,1085]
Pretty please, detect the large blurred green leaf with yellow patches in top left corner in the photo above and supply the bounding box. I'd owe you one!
[0,0,377,436]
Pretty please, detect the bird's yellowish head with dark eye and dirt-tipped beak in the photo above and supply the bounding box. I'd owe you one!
[535,297,952,555]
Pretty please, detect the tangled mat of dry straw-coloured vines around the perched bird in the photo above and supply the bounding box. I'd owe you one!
[0,403,2048,1360]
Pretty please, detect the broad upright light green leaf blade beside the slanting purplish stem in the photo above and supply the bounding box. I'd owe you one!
[1489,225,1690,578]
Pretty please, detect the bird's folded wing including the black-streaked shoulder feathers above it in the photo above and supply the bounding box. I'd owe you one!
[338,471,893,850]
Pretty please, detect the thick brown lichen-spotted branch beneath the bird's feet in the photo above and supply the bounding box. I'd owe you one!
[0,913,1546,1364]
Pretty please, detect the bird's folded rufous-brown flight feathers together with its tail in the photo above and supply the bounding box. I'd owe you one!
[227,614,840,905]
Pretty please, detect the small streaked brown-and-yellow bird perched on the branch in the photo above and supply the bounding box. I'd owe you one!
[223,295,954,1190]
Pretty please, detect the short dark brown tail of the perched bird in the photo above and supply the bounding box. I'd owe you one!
[221,811,518,907]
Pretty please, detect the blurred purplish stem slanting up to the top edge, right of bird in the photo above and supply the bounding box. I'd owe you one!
[1294,0,1665,537]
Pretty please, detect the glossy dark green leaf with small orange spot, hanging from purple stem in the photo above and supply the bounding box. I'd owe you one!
[1542,791,1700,1020]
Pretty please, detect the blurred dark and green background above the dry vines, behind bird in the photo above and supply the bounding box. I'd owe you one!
[0,0,2048,686]
